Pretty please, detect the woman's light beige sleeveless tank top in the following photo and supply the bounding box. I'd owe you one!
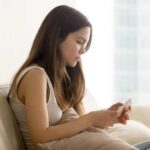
[9,65,62,150]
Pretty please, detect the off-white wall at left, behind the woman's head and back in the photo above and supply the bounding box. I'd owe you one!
[0,0,75,84]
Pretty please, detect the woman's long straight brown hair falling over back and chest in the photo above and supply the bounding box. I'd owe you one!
[8,5,92,115]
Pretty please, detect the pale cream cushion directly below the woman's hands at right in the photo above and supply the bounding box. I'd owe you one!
[107,120,150,144]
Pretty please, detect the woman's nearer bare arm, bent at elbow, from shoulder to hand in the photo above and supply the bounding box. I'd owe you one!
[20,69,117,143]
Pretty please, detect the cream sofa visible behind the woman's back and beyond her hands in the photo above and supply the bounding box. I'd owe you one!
[0,85,150,150]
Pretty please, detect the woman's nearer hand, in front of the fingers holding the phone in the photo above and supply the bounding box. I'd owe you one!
[89,109,118,129]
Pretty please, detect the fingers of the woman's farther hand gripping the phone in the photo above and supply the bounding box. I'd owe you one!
[108,102,131,124]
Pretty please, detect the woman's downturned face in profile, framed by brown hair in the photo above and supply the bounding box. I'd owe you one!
[59,27,91,67]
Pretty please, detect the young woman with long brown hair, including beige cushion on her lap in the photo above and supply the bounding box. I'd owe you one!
[8,5,139,150]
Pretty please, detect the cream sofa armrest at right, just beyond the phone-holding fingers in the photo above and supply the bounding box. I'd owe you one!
[130,104,150,127]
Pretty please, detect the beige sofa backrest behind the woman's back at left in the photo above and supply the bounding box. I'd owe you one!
[0,85,24,150]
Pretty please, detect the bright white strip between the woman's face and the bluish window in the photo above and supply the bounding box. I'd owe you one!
[77,0,114,107]
